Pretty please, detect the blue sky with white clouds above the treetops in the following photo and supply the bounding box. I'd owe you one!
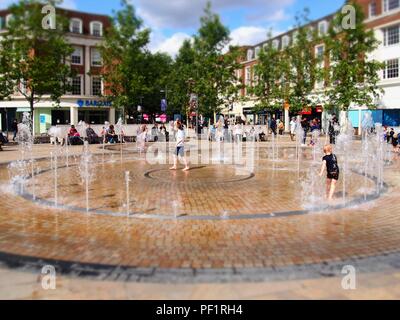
[0,0,344,56]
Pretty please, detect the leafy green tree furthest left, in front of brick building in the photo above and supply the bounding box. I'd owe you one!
[0,0,74,123]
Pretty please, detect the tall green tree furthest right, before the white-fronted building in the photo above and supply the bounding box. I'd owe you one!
[326,1,384,111]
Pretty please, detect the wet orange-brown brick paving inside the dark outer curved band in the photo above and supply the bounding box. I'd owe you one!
[0,144,400,296]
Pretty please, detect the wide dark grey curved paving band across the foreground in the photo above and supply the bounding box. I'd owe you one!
[0,250,400,284]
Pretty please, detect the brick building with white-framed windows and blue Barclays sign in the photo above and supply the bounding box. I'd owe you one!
[0,9,116,134]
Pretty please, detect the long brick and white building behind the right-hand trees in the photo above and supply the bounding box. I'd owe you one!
[228,0,400,129]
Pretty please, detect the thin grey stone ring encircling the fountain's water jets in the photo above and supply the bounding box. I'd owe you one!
[2,158,389,221]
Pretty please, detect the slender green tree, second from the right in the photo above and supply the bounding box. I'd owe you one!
[284,9,322,112]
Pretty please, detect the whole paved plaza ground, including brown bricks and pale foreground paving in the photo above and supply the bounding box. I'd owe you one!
[0,138,400,299]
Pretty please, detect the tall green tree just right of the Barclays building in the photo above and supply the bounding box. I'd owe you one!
[100,0,150,119]
